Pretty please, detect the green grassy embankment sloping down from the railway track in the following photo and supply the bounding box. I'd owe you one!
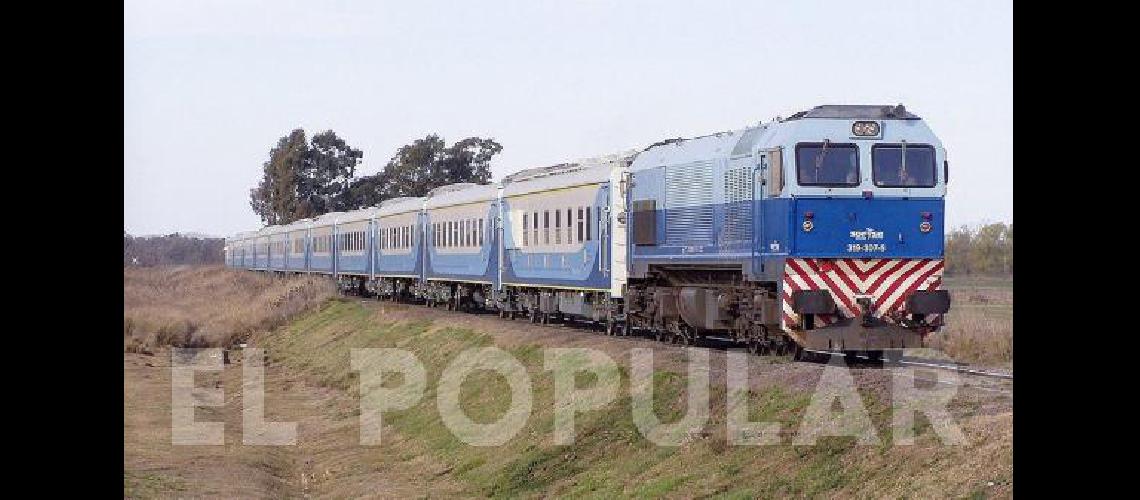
[253,300,1012,498]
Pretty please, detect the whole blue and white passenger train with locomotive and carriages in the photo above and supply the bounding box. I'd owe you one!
[225,105,951,359]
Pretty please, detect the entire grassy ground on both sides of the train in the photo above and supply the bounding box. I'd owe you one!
[123,268,1012,498]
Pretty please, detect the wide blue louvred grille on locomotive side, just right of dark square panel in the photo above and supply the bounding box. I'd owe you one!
[665,161,713,245]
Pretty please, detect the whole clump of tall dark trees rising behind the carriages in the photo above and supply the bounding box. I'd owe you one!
[250,129,503,224]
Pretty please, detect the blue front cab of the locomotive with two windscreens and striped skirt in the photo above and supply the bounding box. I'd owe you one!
[760,106,950,351]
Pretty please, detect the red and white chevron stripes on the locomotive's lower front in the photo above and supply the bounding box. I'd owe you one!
[781,259,943,329]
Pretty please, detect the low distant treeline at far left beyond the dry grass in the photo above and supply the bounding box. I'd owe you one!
[123,231,226,267]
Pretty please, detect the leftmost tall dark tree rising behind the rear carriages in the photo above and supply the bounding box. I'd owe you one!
[250,129,308,224]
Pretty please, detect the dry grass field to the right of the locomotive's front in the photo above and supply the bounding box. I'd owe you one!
[928,277,1013,367]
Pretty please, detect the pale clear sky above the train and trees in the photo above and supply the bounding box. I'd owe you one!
[123,0,1013,236]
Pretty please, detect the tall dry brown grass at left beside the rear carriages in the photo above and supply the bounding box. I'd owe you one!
[123,265,336,352]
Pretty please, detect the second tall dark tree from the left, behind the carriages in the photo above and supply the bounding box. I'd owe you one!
[298,130,364,219]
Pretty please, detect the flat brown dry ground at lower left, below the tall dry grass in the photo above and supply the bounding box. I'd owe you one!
[123,351,463,498]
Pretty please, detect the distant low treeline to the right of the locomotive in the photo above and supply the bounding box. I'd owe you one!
[946,222,1013,274]
